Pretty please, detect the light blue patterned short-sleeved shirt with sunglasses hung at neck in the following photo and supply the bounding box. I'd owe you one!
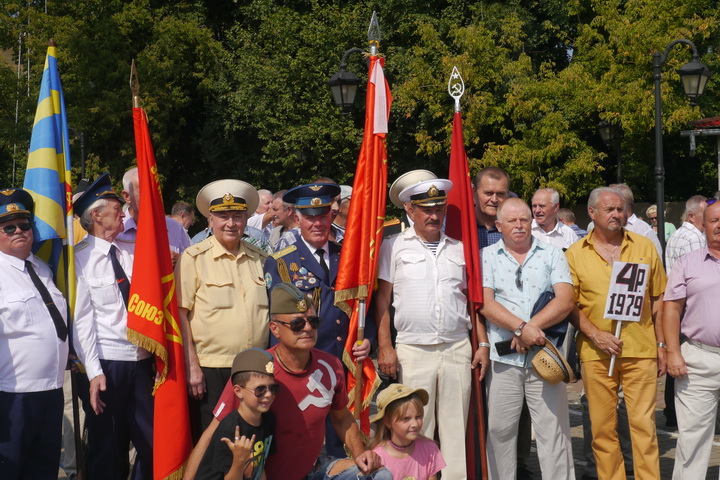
[482,239,572,367]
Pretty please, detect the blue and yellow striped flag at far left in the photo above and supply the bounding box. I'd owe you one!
[23,44,75,303]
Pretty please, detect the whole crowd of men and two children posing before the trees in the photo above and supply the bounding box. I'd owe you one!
[0,163,720,480]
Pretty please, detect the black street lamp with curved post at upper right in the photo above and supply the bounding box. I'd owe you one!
[653,39,713,263]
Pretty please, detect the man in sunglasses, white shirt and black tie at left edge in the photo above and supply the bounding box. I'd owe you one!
[0,189,68,480]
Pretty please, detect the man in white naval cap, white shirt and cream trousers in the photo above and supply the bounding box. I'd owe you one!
[375,178,480,480]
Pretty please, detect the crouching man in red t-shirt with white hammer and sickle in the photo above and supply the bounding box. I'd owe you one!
[183,283,392,480]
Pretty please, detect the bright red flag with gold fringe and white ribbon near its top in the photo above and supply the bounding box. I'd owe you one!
[335,55,392,434]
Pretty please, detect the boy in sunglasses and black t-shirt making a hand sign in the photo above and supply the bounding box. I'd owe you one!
[195,348,280,480]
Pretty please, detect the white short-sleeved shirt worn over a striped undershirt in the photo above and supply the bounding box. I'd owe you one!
[378,227,471,345]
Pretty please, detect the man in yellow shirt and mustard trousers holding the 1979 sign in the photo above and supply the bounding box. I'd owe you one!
[566,187,666,480]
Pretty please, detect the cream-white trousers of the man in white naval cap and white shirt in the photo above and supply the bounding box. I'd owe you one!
[397,339,472,480]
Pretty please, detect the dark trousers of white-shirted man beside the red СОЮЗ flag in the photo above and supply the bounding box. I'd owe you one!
[81,358,155,480]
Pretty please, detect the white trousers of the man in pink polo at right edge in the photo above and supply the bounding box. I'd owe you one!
[673,342,720,480]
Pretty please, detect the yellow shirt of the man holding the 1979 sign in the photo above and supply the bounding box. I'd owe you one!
[565,230,667,362]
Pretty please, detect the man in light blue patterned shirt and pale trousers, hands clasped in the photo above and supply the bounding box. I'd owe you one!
[482,199,575,479]
